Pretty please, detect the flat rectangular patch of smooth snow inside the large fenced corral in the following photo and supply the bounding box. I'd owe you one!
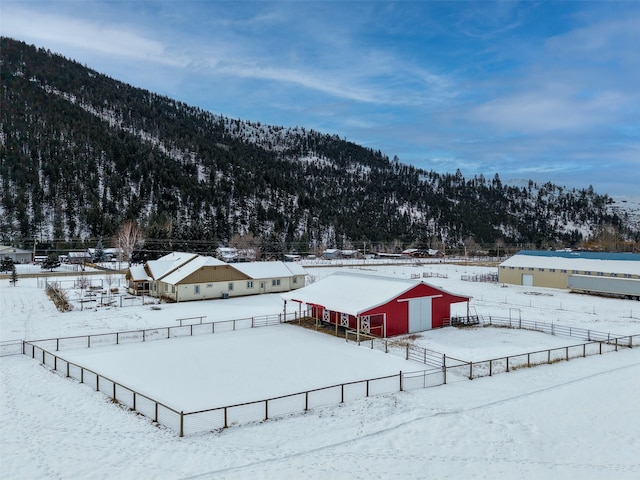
[55,324,426,412]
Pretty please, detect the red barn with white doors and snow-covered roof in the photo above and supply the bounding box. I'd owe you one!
[281,272,471,337]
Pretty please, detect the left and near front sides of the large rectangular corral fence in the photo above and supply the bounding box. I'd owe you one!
[22,342,445,437]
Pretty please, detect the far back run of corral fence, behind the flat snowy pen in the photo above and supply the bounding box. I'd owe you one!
[25,312,297,352]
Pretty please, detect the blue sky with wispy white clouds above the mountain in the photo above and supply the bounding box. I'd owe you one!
[0,0,640,195]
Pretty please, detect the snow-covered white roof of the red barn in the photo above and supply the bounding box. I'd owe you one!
[280,272,468,316]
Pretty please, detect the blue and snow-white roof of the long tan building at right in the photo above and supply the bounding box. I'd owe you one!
[500,250,640,275]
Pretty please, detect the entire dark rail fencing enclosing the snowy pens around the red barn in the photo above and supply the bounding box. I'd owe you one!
[17,313,640,437]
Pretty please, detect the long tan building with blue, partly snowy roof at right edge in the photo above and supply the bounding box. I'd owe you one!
[498,250,640,289]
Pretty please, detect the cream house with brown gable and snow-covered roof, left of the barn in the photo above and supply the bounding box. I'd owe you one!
[127,252,306,302]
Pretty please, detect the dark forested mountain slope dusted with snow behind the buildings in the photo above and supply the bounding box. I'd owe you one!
[0,38,637,251]
